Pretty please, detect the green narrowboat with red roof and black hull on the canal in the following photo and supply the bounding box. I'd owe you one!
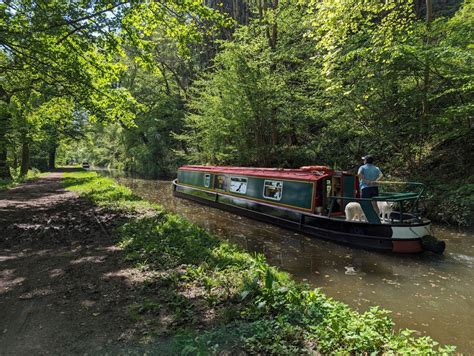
[173,165,445,254]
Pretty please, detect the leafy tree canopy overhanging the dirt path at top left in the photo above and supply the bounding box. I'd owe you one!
[0,0,224,175]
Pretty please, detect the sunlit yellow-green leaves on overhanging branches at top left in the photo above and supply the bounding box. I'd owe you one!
[0,0,229,176]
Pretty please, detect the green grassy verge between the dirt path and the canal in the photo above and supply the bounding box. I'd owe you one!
[64,172,455,355]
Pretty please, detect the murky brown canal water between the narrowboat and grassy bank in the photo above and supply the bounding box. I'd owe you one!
[98,171,474,354]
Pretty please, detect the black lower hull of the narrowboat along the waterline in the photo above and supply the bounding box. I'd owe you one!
[173,181,445,253]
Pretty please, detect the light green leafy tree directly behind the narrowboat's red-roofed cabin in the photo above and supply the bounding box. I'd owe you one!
[178,1,324,166]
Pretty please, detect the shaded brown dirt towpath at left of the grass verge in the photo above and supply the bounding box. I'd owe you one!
[0,173,154,355]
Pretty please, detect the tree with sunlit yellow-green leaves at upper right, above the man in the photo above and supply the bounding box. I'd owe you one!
[309,0,470,170]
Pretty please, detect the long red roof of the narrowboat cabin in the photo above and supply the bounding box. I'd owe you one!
[179,165,334,181]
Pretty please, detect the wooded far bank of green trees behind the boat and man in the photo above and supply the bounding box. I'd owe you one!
[173,0,474,224]
